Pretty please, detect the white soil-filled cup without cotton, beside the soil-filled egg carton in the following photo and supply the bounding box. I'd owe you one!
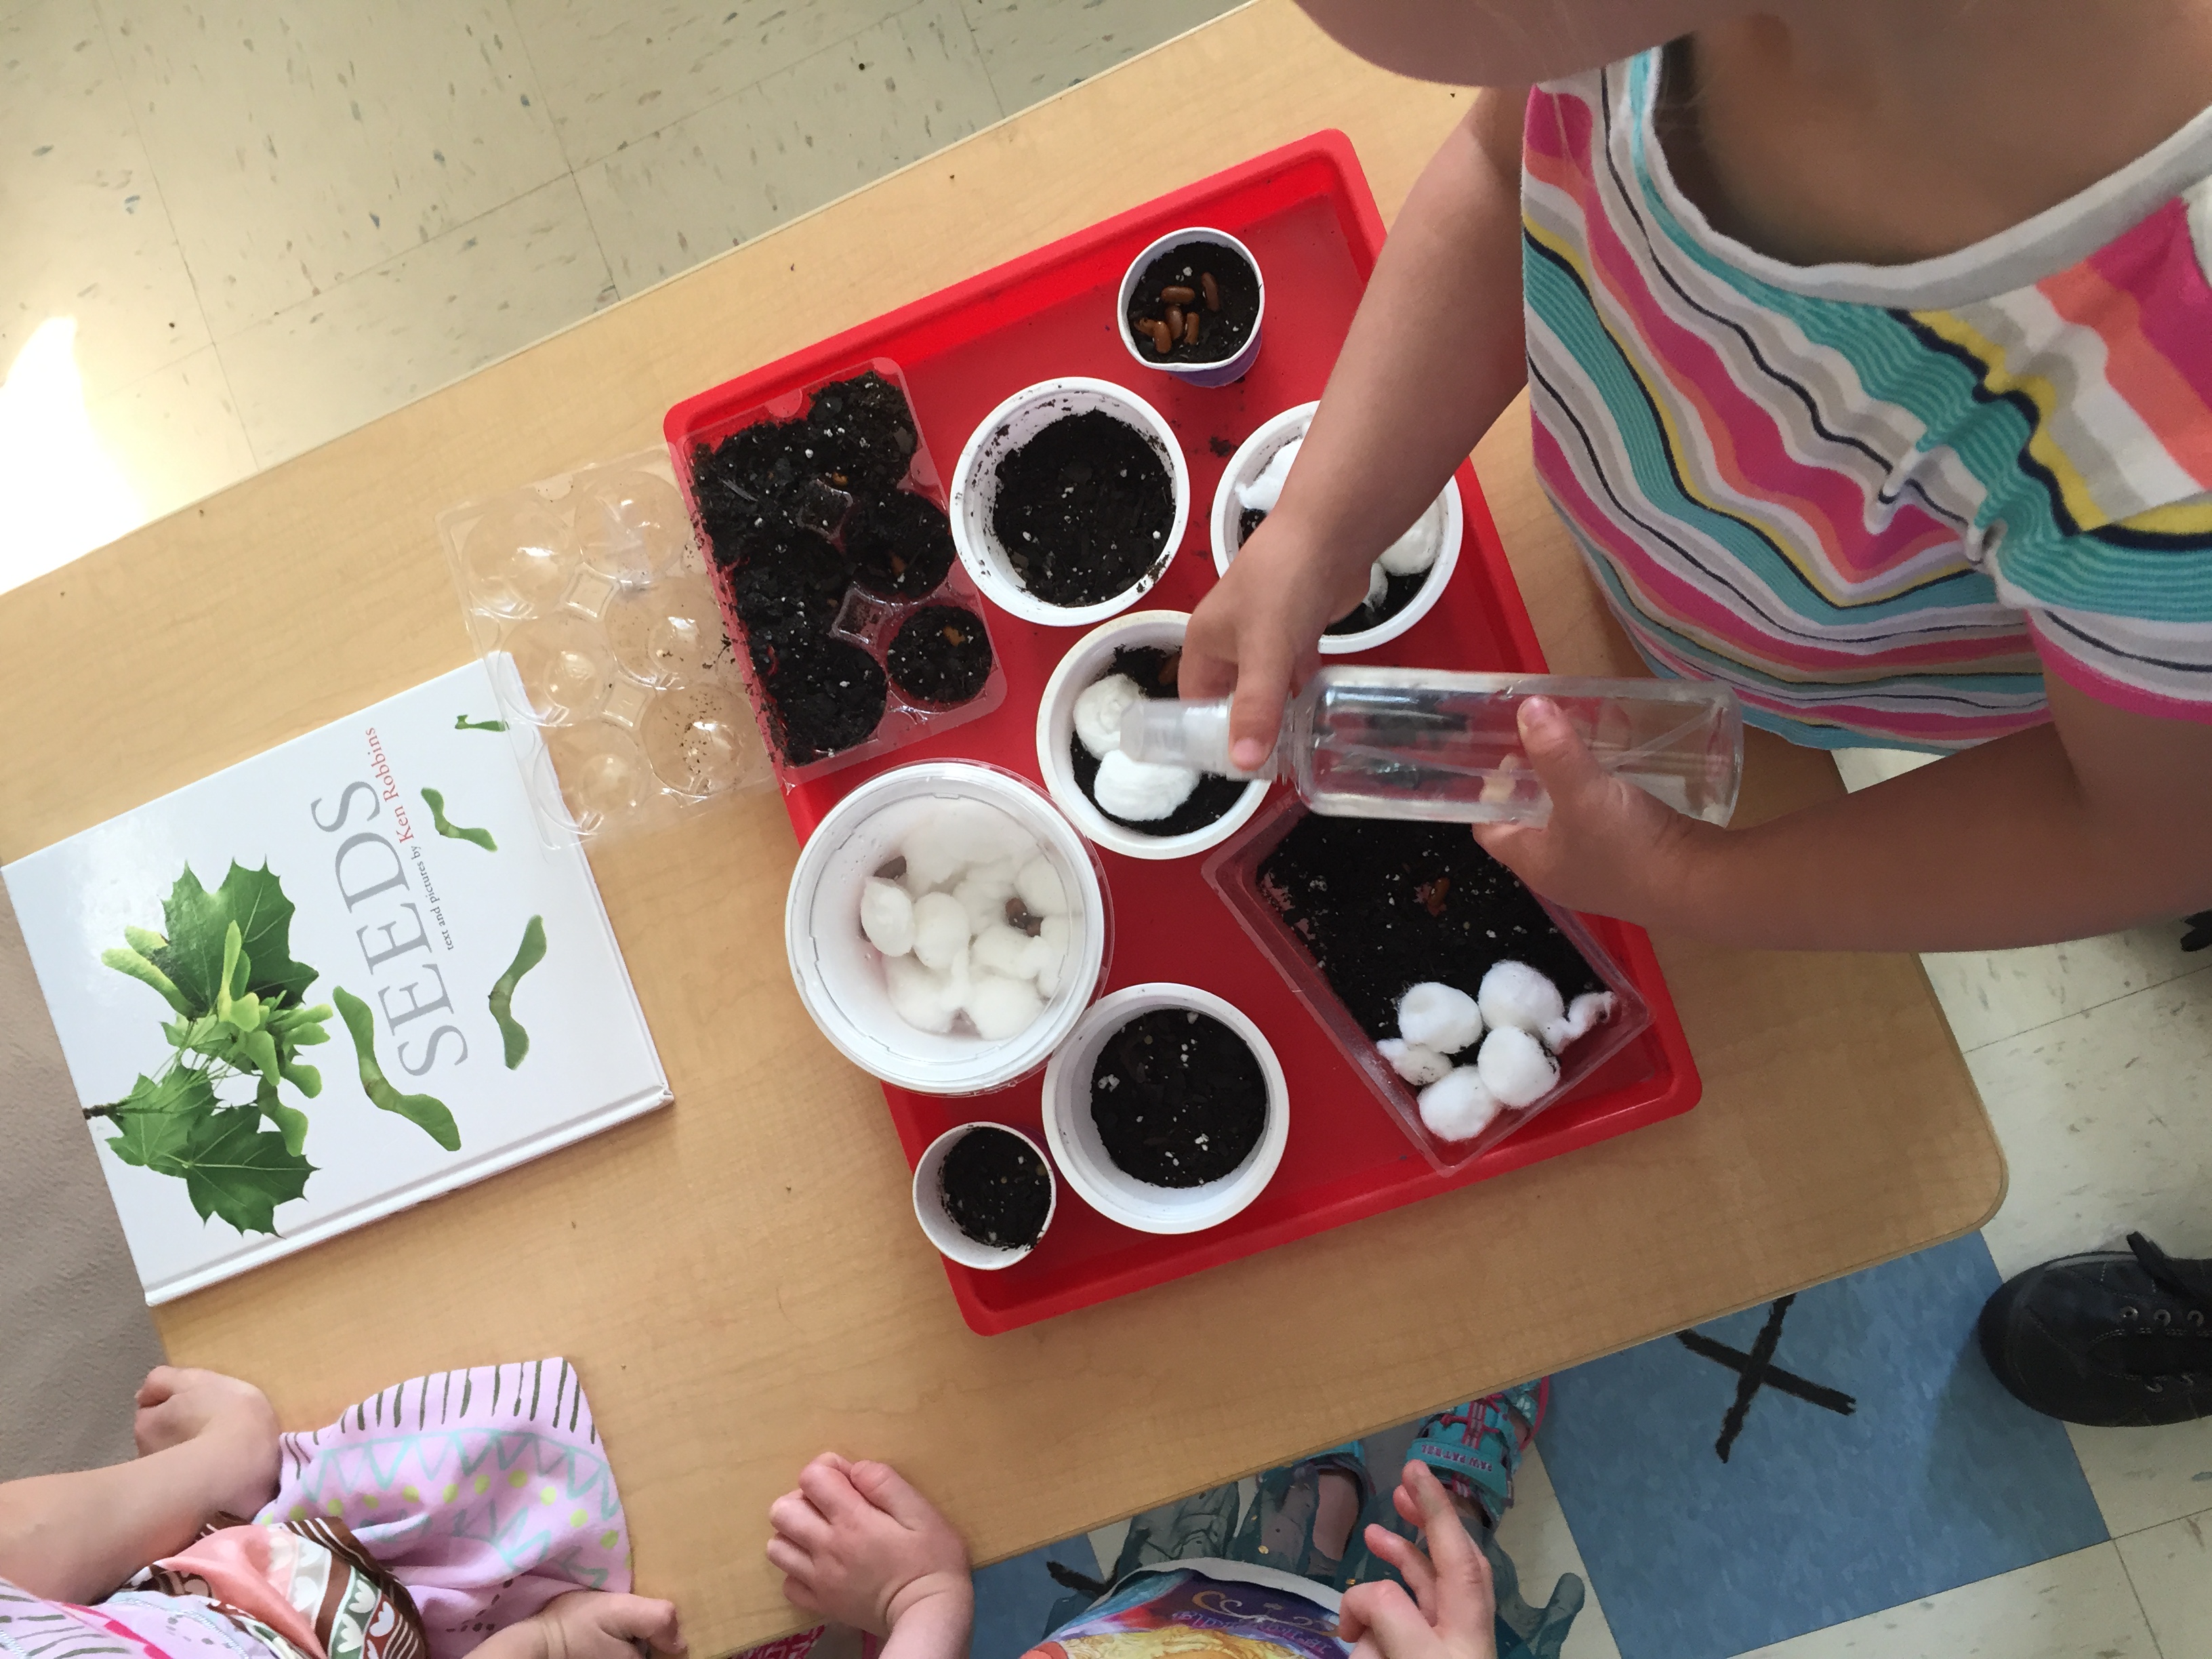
[951,378,1190,628]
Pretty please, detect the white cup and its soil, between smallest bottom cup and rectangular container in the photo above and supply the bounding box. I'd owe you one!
[1044,984,1290,1232]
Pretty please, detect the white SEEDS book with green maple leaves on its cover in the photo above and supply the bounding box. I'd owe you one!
[0,657,668,1303]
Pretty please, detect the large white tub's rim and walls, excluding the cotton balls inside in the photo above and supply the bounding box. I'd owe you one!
[783,761,1113,1095]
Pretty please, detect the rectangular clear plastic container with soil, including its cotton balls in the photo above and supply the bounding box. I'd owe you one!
[1203,798,1652,1179]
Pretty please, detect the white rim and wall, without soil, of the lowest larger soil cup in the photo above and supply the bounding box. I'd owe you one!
[1044,984,1290,1232]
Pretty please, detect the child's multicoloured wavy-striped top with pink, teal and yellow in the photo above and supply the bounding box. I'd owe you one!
[1522,51,2212,750]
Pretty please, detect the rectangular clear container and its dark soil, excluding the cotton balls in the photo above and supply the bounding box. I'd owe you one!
[1206,801,1650,1172]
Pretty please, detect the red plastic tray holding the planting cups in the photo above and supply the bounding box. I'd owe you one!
[663,133,1701,1334]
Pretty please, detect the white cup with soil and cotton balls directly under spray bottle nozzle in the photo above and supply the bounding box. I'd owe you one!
[1038,611,1267,858]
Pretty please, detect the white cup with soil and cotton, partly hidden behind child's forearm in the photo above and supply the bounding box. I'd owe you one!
[1208,403,1467,657]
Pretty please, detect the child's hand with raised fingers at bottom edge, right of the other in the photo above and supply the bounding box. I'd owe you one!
[1336,1462,1498,1659]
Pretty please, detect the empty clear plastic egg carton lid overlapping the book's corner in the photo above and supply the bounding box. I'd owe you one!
[438,449,774,845]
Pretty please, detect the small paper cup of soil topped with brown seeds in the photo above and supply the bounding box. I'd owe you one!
[1115,226,1267,387]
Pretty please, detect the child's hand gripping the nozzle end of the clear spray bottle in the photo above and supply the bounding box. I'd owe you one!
[1179,511,1367,772]
